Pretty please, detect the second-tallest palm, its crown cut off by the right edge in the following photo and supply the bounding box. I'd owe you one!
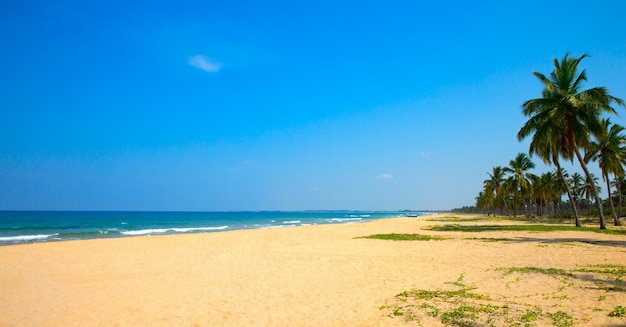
[585,118,626,226]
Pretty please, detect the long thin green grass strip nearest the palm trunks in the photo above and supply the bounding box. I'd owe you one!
[424,224,626,235]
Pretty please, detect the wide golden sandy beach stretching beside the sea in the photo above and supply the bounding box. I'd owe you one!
[0,216,626,326]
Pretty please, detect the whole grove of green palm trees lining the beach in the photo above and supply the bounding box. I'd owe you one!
[468,54,626,229]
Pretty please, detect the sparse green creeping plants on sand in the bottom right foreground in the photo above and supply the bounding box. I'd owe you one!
[380,264,626,327]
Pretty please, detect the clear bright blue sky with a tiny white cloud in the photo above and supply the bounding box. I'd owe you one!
[0,0,626,210]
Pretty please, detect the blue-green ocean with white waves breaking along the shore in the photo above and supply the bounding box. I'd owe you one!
[0,211,424,246]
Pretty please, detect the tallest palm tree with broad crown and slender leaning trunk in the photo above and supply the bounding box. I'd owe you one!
[522,54,624,229]
